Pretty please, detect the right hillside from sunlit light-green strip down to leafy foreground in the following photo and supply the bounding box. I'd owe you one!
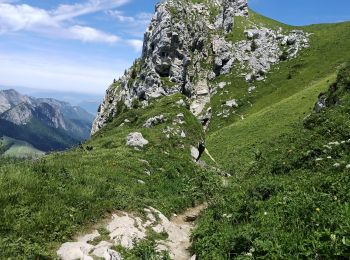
[193,62,350,259]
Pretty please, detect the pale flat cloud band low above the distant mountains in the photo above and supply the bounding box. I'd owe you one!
[0,53,130,94]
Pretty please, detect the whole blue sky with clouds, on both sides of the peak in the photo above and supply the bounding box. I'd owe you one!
[0,0,350,95]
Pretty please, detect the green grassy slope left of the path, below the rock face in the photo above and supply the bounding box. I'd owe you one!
[0,95,217,259]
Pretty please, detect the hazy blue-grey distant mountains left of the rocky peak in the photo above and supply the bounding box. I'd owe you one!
[0,89,94,156]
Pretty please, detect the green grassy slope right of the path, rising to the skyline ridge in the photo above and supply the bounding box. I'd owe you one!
[194,16,350,259]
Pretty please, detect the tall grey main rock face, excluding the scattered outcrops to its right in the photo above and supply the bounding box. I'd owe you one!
[92,0,247,134]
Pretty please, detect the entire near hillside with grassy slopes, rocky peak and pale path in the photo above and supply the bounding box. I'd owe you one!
[0,0,350,260]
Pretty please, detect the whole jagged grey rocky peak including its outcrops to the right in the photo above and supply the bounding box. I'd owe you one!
[91,0,308,134]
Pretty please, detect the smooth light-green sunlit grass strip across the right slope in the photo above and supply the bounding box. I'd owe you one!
[207,75,335,173]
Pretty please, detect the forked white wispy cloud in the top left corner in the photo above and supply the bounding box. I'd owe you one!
[0,0,130,43]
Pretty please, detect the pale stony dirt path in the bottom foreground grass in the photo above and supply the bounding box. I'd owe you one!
[57,204,207,260]
